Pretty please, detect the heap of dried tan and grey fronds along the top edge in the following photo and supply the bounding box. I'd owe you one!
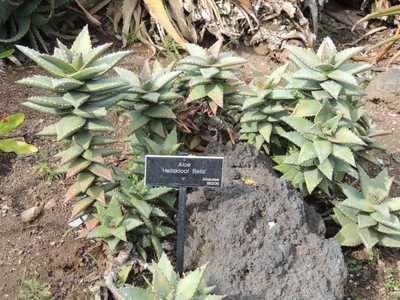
[82,0,326,50]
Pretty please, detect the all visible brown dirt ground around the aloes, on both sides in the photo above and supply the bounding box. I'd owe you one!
[0,2,400,300]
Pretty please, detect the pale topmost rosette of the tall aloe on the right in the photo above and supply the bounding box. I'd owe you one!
[287,37,370,100]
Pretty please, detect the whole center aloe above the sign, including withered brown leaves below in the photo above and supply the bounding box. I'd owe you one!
[176,41,246,151]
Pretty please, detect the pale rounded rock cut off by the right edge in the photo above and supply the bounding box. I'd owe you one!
[364,69,400,113]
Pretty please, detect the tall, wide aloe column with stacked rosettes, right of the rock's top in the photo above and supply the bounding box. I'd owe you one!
[255,38,381,194]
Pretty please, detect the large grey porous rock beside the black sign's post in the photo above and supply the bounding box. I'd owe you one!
[185,145,347,300]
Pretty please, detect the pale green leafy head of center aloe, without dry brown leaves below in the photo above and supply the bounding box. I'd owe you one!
[177,40,247,115]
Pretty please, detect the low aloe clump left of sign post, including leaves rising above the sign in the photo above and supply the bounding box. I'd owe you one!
[72,129,180,258]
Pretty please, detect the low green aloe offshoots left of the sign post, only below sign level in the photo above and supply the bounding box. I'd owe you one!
[83,169,176,255]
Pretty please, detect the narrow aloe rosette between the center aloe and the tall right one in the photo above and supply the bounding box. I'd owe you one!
[239,65,296,153]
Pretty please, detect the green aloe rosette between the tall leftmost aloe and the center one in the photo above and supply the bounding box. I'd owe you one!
[115,61,181,138]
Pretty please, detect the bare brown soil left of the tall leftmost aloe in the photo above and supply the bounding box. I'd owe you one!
[0,68,105,299]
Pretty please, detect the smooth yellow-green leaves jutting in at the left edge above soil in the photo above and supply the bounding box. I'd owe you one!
[0,113,38,154]
